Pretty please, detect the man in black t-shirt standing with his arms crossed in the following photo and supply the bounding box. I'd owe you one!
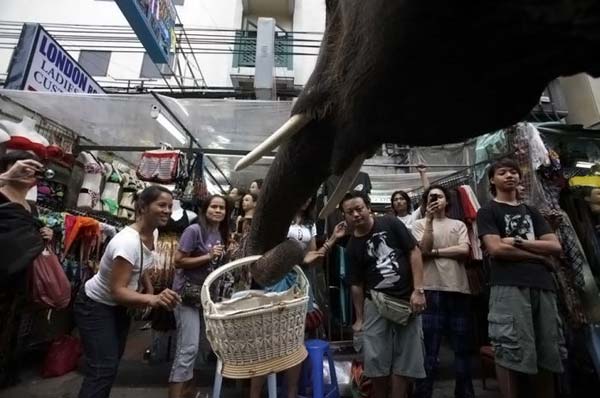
[477,159,562,398]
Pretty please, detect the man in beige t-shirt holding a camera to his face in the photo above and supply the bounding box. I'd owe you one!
[412,185,474,398]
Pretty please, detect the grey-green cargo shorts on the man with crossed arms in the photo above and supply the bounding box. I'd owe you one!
[488,286,564,374]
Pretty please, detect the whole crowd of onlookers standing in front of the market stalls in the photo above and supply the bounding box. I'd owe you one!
[0,154,562,398]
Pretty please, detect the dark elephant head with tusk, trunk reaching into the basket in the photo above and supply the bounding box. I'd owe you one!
[233,0,600,284]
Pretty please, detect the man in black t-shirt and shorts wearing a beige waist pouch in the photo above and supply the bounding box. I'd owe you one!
[340,193,425,398]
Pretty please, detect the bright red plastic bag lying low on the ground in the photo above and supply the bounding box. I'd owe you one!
[41,335,83,377]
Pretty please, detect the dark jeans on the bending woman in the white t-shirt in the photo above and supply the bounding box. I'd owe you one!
[74,287,130,398]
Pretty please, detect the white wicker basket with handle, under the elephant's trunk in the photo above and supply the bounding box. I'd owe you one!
[201,256,309,378]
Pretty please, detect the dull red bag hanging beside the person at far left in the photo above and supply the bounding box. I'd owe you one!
[29,247,71,309]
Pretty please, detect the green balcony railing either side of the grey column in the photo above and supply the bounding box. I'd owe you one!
[233,30,294,70]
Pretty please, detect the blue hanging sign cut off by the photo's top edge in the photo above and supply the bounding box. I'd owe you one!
[115,0,177,64]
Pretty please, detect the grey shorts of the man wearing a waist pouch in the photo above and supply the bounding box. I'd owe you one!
[362,299,426,379]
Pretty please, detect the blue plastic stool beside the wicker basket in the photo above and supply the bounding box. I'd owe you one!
[299,340,340,398]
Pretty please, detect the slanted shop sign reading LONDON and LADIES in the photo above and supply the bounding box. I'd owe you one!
[4,23,104,94]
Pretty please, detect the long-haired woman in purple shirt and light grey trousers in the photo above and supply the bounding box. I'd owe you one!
[169,195,230,398]
